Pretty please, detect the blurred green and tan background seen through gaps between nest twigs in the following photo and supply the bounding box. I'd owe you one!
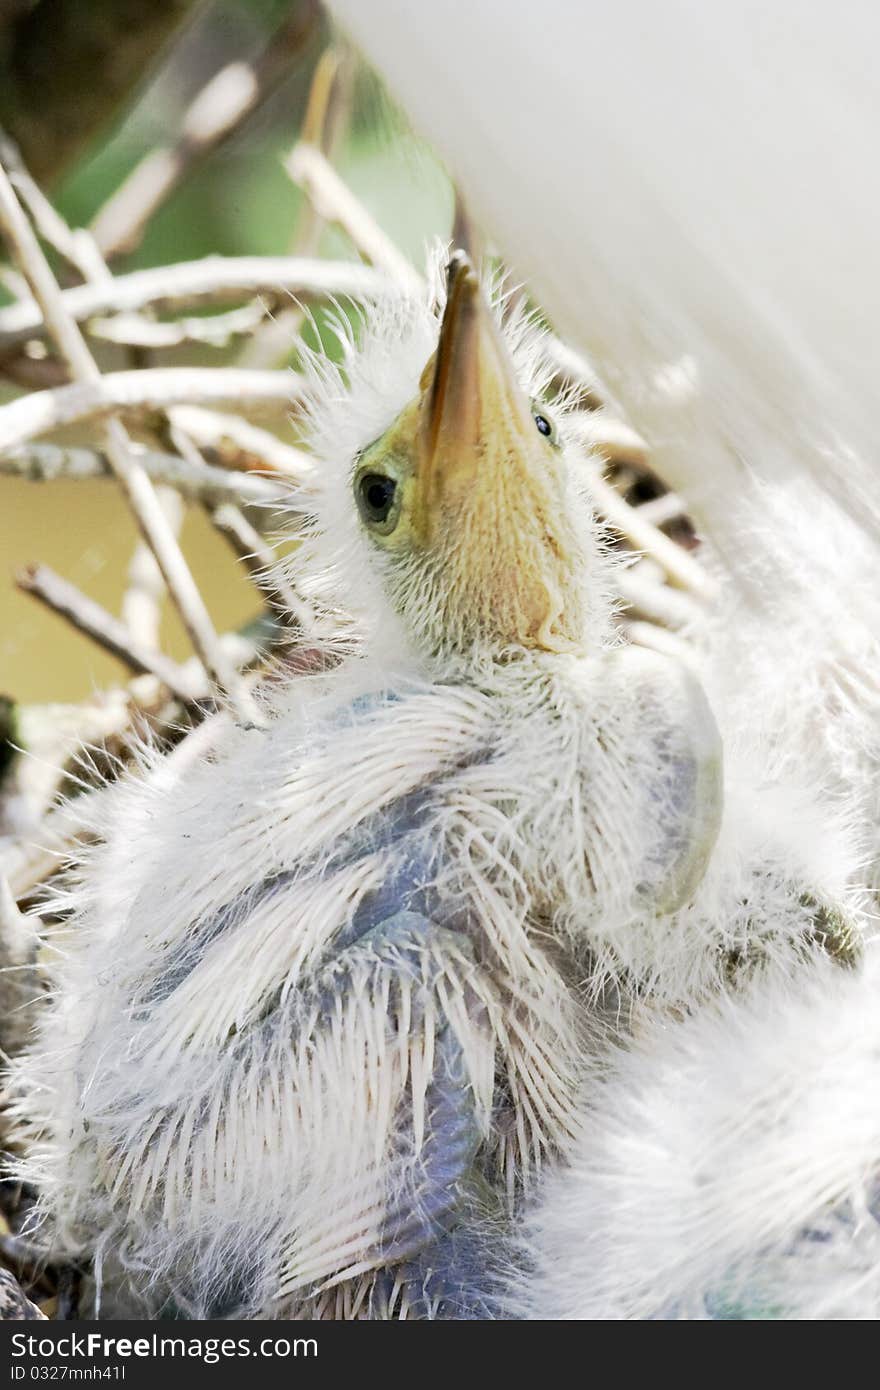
[0,0,453,702]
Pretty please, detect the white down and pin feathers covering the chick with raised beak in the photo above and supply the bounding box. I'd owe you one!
[15,265,863,1315]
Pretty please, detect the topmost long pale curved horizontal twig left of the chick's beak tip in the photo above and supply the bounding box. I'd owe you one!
[0,256,391,353]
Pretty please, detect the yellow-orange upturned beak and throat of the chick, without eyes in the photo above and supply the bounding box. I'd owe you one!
[413,253,584,651]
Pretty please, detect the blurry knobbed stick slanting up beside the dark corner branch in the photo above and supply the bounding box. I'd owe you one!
[92,3,317,260]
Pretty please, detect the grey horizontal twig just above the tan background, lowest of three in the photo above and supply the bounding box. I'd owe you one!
[0,442,287,507]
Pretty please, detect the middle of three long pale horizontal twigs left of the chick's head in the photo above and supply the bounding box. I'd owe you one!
[0,367,298,453]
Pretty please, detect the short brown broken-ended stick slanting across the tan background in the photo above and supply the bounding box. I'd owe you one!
[15,564,199,705]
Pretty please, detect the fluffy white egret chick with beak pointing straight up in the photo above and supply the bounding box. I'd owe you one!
[13,256,842,1318]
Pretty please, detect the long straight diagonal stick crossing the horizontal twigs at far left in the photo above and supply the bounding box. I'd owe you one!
[0,165,254,717]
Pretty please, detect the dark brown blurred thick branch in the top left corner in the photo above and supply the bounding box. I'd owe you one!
[0,0,196,181]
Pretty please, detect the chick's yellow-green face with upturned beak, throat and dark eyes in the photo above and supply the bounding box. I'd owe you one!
[329,253,591,667]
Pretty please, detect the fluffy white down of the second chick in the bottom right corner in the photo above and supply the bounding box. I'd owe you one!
[516,945,880,1319]
